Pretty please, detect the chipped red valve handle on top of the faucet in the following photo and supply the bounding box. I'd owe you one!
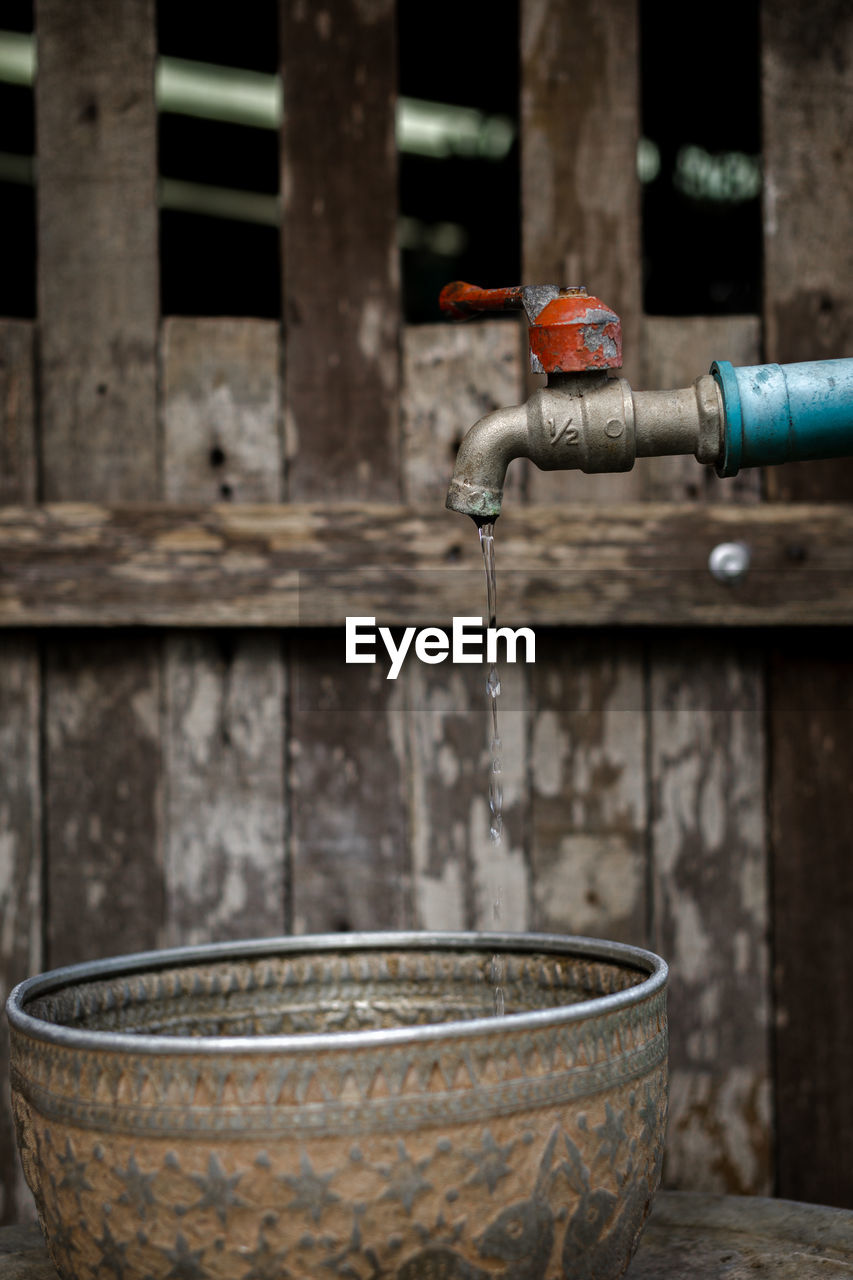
[438,280,622,374]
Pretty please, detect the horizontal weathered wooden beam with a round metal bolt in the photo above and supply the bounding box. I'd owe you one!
[0,503,853,627]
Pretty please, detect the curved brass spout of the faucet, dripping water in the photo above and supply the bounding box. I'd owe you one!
[447,404,528,525]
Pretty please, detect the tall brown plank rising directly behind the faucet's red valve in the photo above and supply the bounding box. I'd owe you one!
[521,0,642,504]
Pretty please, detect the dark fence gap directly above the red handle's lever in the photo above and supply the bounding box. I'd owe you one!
[397,0,521,321]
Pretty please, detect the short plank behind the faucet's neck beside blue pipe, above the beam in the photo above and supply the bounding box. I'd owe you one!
[637,316,761,502]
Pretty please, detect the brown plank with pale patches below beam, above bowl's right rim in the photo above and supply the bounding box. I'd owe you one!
[530,631,647,943]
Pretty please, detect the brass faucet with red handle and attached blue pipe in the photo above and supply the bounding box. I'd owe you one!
[439,282,853,525]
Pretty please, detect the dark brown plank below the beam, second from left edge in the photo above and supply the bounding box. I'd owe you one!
[45,632,164,966]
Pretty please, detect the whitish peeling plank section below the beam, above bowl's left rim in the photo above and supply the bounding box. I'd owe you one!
[164,631,286,946]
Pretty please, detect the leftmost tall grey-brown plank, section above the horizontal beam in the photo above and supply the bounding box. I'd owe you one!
[36,0,159,500]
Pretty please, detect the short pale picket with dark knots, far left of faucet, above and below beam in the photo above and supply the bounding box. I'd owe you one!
[163,319,286,945]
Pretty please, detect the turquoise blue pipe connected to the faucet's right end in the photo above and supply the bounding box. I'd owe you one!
[711,360,853,476]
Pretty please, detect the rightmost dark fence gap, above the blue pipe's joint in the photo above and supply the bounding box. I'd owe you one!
[638,0,762,315]
